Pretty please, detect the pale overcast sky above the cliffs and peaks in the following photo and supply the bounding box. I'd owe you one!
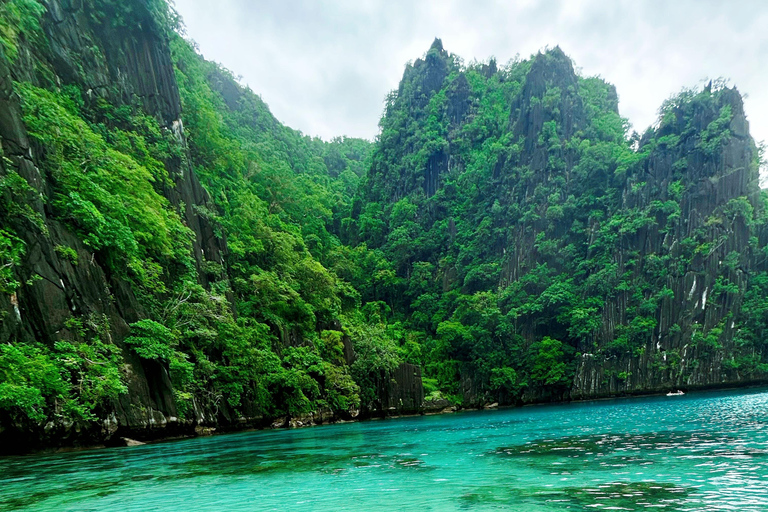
[175,0,768,150]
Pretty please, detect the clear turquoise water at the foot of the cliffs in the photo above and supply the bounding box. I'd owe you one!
[0,391,768,512]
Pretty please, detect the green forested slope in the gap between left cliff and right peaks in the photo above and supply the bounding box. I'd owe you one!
[166,33,370,415]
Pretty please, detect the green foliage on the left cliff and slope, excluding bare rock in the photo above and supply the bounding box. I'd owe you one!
[0,0,376,428]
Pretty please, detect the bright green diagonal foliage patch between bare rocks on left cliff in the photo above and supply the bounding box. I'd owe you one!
[17,83,193,291]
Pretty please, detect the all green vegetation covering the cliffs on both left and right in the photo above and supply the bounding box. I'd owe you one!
[0,0,768,440]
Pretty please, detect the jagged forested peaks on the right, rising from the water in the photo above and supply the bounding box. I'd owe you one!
[352,40,768,404]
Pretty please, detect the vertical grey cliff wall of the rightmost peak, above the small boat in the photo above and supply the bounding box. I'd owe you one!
[573,86,766,398]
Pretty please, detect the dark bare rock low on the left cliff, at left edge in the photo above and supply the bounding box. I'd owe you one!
[0,48,181,447]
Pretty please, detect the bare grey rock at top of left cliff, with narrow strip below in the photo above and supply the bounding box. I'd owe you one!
[39,0,226,285]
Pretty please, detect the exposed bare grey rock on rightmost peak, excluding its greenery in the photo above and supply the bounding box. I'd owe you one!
[571,89,768,399]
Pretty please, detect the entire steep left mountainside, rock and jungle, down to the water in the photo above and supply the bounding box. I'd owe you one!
[0,0,404,452]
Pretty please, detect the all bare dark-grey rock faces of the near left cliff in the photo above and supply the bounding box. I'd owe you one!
[0,0,226,449]
